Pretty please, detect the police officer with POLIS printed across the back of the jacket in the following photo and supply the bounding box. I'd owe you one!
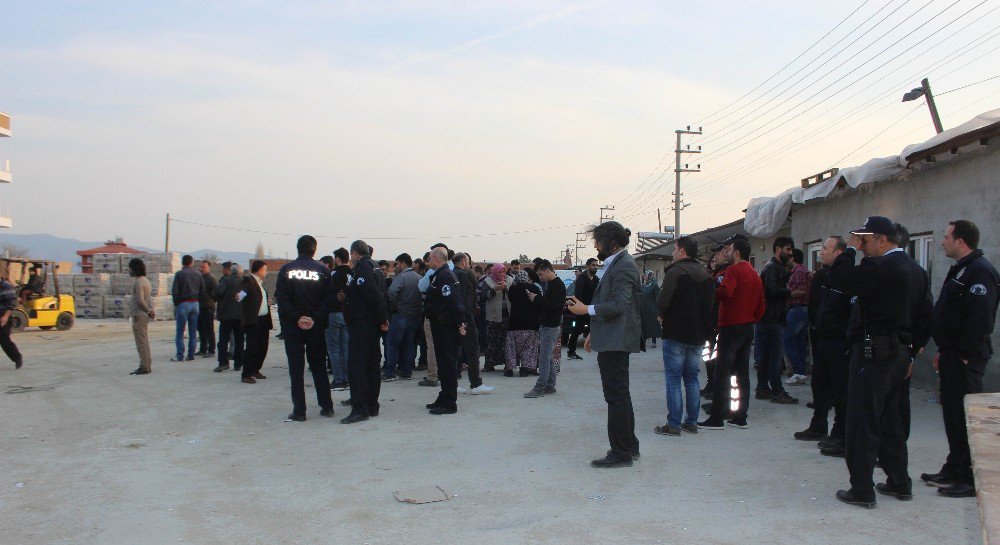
[274,235,333,422]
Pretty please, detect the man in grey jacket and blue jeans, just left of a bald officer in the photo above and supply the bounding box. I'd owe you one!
[382,253,423,382]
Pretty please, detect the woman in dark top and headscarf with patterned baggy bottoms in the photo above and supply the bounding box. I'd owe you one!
[503,270,542,377]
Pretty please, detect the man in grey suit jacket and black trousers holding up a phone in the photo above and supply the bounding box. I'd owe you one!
[567,221,642,468]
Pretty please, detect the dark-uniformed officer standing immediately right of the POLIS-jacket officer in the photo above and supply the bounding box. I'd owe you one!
[340,240,389,424]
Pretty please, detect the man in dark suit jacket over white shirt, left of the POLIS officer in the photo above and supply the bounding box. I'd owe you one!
[236,260,274,384]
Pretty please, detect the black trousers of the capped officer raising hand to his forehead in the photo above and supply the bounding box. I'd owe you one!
[845,338,911,499]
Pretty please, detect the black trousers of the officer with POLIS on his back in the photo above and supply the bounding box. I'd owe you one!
[284,327,333,416]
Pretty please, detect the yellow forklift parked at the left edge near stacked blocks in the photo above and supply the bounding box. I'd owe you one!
[0,258,76,331]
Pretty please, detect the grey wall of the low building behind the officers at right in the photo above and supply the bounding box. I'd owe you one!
[792,142,1000,391]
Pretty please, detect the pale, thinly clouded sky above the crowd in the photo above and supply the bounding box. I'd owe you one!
[0,0,1000,261]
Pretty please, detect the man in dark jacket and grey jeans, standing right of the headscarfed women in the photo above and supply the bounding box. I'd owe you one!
[524,259,566,398]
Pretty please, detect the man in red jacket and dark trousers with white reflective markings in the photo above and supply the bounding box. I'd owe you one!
[698,235,764,430]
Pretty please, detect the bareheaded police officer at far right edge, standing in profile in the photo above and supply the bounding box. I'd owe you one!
[920,220,1000,498]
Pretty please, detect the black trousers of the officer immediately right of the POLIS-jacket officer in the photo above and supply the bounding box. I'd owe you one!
[350,324,382,416]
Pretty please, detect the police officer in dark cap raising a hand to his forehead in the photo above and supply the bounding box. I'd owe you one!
[827,216,931,509]
